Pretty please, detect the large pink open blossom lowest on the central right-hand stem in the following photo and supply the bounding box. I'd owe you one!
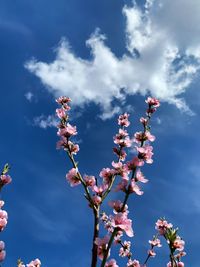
[111,212,133,237]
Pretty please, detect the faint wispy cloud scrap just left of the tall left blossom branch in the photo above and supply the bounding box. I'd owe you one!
[33,115,58,129]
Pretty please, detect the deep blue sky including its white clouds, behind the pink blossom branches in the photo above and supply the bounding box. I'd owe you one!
[0,0,200,267]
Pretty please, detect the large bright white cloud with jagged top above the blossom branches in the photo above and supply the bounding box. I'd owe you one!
[25,0,200,119]
